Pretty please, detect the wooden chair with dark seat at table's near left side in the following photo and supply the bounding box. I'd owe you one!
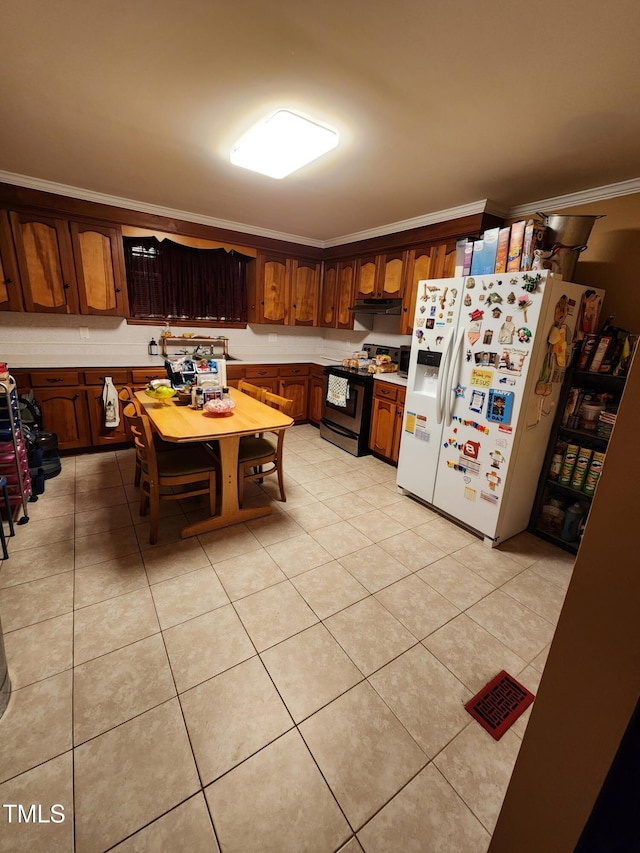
[124,403,219,545]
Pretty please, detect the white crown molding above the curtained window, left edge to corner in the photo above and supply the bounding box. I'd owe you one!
[0,170,324,249]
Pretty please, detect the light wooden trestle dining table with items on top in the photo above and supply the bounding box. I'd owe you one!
[136,388,293,539]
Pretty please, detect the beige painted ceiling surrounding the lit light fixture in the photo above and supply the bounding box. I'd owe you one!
[0,0,640,245]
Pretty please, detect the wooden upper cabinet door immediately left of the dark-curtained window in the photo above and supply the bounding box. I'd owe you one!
[70,222,128,317]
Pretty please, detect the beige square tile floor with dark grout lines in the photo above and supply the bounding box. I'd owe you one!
[0,425,573,853]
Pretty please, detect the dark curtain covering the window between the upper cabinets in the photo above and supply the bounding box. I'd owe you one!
[123,237,252,323]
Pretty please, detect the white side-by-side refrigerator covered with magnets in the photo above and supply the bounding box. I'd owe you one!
[397,270,604,546]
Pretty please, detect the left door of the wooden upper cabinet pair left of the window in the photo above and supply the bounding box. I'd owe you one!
[10,213,78,314]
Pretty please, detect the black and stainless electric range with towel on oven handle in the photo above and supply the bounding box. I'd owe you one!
[320,344,400,456]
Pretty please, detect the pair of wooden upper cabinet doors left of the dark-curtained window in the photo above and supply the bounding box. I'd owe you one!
[9,212,128,317]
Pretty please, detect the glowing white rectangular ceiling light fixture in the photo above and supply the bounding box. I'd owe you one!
[230,110,338,178]
